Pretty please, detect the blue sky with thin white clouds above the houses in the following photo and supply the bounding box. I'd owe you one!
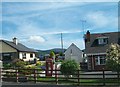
[0,0,118,50]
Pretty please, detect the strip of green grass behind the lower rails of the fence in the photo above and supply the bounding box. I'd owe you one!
[27,77,120,85]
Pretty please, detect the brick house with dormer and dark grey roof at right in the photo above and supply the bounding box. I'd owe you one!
[85,31,120,70]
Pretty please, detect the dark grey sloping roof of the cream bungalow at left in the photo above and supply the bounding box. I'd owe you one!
[0,40,36,52]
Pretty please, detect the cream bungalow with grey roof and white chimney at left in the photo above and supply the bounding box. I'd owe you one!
[0,38,36,62]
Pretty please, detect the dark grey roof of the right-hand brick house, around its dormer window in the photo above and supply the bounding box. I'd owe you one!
[85,32,120,54]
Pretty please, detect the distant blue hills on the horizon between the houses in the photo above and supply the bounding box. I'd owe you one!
[37,48,66,55]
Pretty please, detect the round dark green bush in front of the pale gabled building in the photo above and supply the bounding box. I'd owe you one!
[60,60,79,79]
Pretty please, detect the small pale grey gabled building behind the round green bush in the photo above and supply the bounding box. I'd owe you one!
[65,43,83,64]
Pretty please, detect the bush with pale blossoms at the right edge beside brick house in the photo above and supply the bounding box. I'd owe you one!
[106,44,120,71]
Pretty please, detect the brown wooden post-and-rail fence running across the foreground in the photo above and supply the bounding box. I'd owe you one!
[1,68,120,86]
